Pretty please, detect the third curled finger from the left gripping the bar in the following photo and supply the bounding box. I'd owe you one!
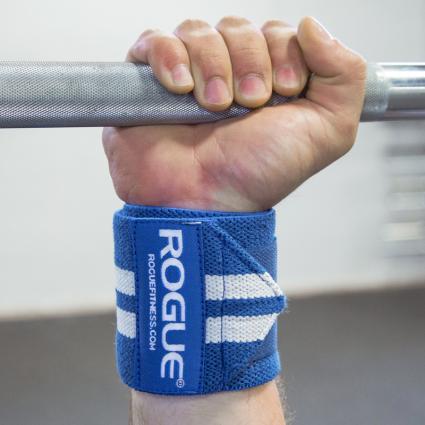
[216,17,273,108]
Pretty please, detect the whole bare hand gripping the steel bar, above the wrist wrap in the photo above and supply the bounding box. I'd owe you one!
[103,17,366,211]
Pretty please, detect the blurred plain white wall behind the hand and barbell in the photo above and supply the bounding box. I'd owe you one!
[0,0,425,316]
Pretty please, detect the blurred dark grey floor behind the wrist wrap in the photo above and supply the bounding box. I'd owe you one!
[0,288,425,425]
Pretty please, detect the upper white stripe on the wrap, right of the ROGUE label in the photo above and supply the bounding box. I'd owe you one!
[205,273,282,300]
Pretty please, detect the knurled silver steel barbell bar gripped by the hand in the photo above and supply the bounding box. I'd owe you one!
[0,62,425,128]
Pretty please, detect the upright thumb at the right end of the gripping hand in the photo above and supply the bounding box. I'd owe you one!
[297,17,366,119]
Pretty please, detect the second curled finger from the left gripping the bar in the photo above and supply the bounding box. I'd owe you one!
[175,20,233,110]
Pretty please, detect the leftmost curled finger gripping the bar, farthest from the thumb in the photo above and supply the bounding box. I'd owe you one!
[127,30,194,94]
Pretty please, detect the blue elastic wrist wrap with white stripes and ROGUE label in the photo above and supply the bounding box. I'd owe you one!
[114,205,285,395]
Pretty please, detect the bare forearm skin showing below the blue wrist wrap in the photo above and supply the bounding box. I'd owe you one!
[130,381,285,425]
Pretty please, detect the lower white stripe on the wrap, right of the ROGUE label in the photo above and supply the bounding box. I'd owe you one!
[205,313,277,344]
